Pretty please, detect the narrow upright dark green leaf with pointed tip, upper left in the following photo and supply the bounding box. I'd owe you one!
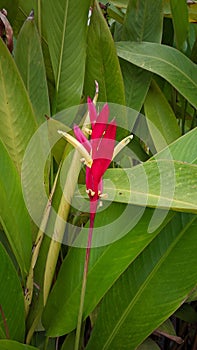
[15,17,50,124]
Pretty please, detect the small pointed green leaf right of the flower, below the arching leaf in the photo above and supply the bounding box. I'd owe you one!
[144,81,180,151]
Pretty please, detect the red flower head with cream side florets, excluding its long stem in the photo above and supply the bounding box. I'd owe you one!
[58,98,133,212]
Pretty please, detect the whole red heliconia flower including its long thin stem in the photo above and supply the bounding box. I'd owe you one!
[58,96,133,349]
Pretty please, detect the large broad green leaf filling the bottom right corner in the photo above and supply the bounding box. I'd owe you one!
[87,214,197,350]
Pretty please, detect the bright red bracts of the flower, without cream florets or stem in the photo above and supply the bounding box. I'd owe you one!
[74,98,117,202]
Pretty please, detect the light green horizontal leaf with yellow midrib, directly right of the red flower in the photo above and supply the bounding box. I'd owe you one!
[104,160,197,213]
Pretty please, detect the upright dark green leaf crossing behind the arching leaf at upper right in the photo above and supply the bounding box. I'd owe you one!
[119,0,163,110]
